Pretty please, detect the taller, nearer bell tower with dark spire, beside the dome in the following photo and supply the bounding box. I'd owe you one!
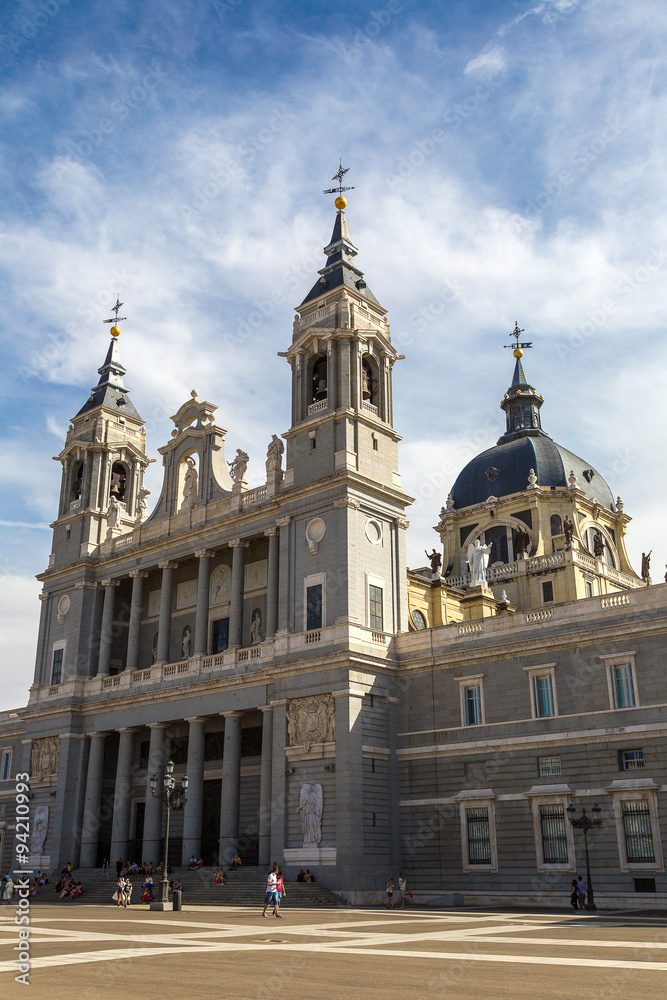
[281,179,402,496]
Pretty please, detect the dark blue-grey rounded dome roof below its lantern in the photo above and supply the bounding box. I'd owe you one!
[452,431,615,510]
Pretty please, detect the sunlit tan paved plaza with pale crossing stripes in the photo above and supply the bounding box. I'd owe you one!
[0,904,667,1000]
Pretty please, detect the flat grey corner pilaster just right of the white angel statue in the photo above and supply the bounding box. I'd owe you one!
[333,690,364,889]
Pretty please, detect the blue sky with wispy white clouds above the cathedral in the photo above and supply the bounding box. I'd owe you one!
[0,0,667,709]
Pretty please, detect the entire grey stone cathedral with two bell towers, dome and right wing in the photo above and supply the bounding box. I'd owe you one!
[0,199,667,906]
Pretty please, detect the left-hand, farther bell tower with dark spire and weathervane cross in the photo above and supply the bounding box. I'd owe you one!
[50,301,150,568]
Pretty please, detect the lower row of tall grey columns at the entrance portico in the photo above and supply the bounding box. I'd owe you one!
[79,701,286,868]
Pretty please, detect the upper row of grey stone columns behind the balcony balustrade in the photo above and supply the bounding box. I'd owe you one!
[97,518,289,677]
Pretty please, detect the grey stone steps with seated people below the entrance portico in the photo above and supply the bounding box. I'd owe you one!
[31,865,348,909]
